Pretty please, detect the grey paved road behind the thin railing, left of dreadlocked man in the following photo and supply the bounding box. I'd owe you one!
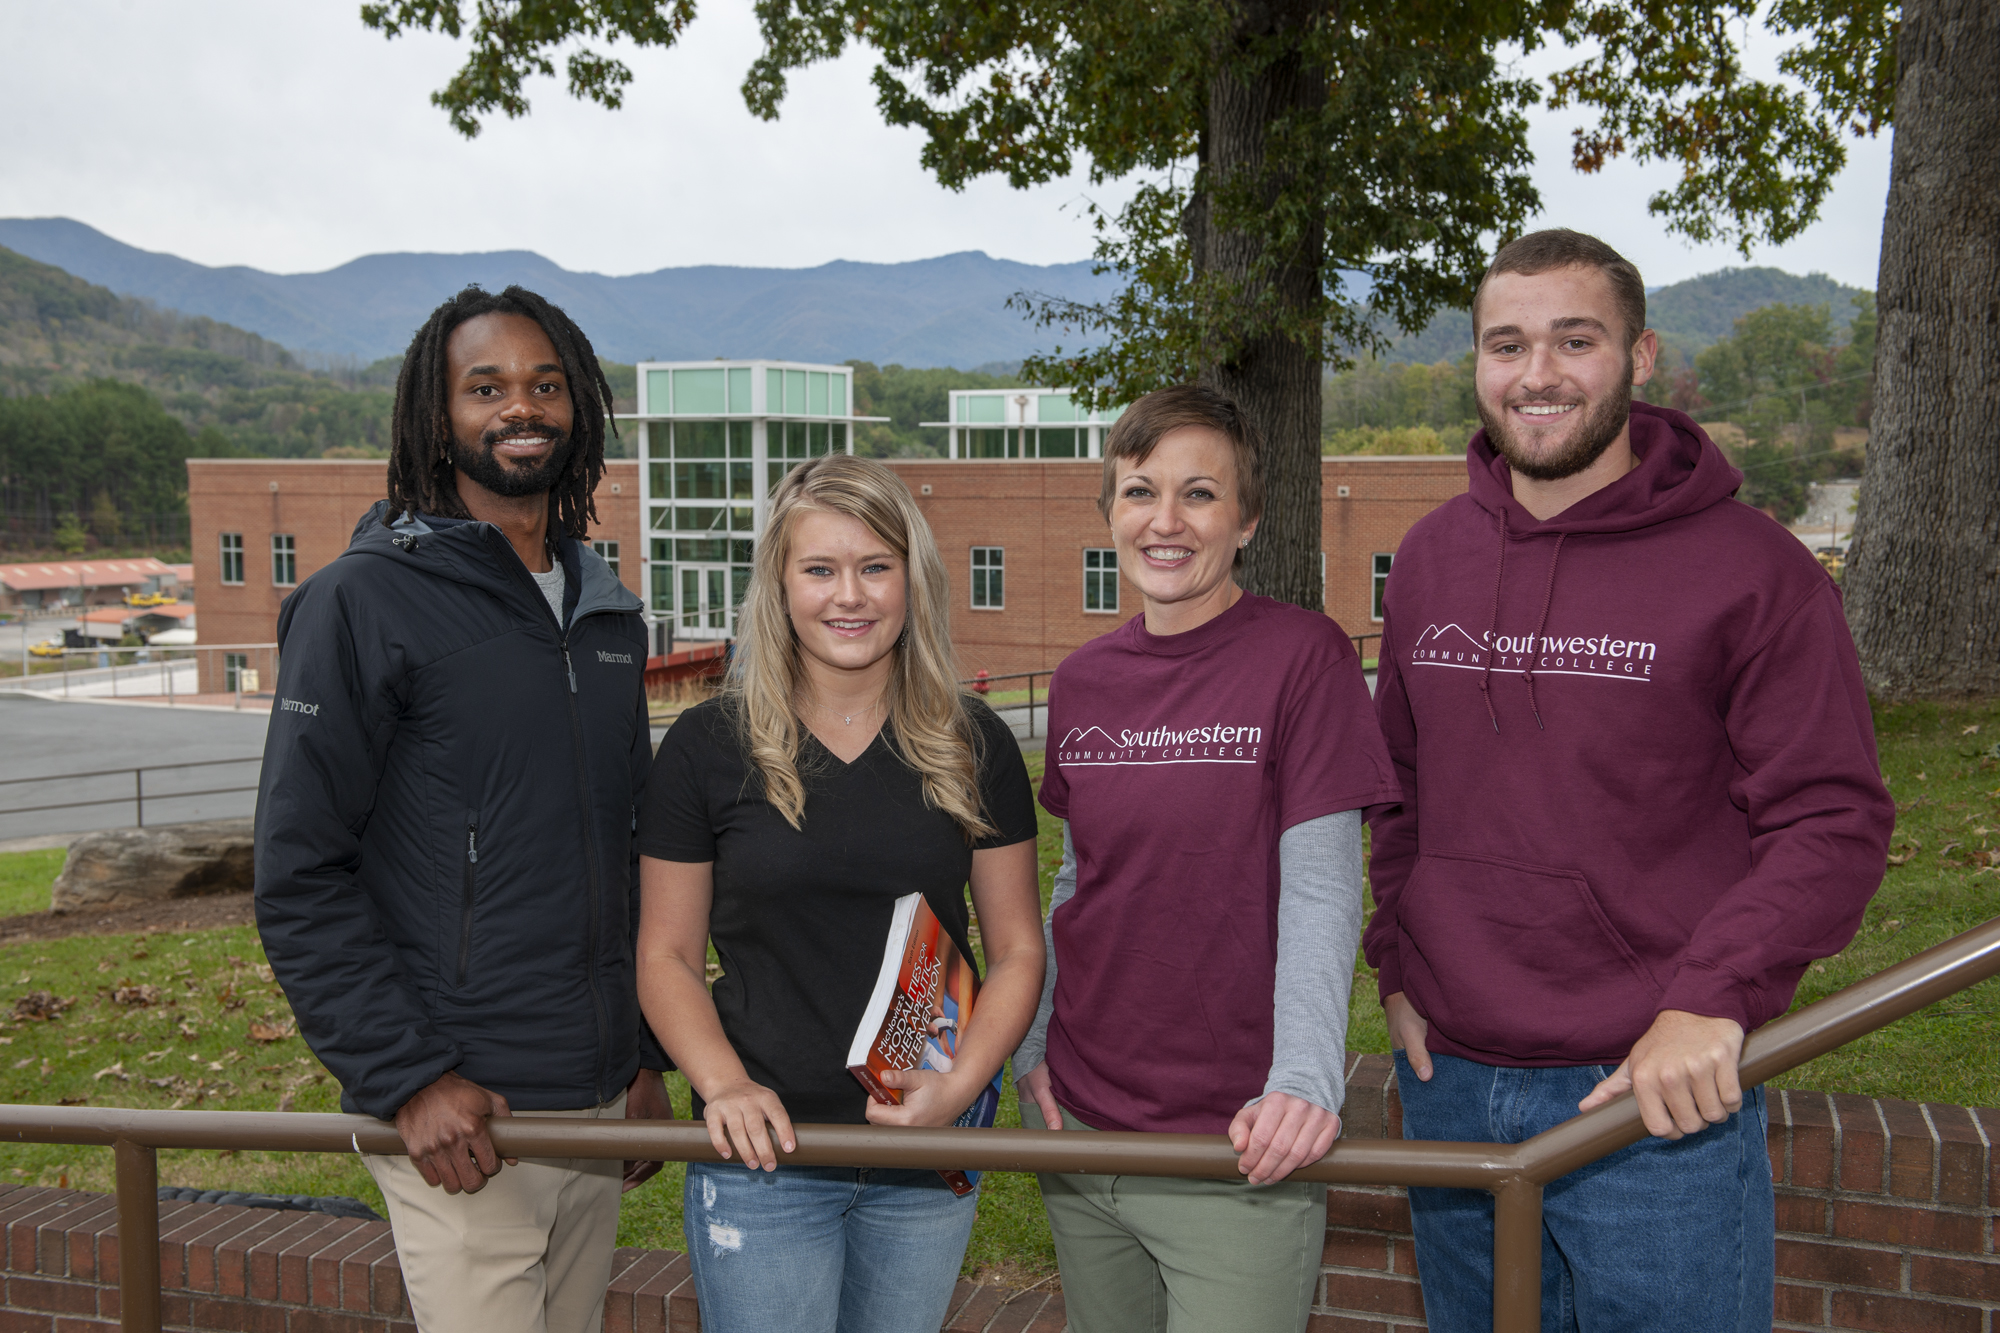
[0,695,270,841]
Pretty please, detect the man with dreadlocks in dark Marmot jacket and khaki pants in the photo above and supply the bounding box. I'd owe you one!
[256,286,672,1333]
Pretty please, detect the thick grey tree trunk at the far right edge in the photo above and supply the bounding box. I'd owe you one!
[1846,0,2000,699]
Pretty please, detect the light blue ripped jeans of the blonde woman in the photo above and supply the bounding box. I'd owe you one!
[682,1163,980,1333]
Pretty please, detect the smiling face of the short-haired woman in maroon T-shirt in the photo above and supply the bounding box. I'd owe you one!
[1110,426,1256,632]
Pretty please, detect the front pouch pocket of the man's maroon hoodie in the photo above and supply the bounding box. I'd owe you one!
[1396,853,1664,1065]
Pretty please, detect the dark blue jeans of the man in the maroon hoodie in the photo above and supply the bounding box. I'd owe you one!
[1396,1051,1776,1333]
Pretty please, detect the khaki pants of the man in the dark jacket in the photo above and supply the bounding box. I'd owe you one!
[362,1093,624,1333]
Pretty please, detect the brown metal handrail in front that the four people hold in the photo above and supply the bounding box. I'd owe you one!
[0,917,2000,1333]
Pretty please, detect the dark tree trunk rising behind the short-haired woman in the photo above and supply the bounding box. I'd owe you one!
[1188,0,1326,610]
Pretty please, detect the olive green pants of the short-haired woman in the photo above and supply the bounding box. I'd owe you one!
[1020,1097,1326,1333]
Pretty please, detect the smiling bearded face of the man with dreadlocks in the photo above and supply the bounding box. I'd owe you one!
[444,314,574,496]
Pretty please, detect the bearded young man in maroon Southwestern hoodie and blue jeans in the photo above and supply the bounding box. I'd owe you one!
[1364,230,1894,1333]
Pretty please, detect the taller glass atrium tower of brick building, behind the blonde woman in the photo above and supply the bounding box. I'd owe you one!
[630,360,856,652]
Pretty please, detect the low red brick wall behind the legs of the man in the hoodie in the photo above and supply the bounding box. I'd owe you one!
[1312,1055,2000,1333]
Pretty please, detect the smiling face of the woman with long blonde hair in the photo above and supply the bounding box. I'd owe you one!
[784,508,910,673]
